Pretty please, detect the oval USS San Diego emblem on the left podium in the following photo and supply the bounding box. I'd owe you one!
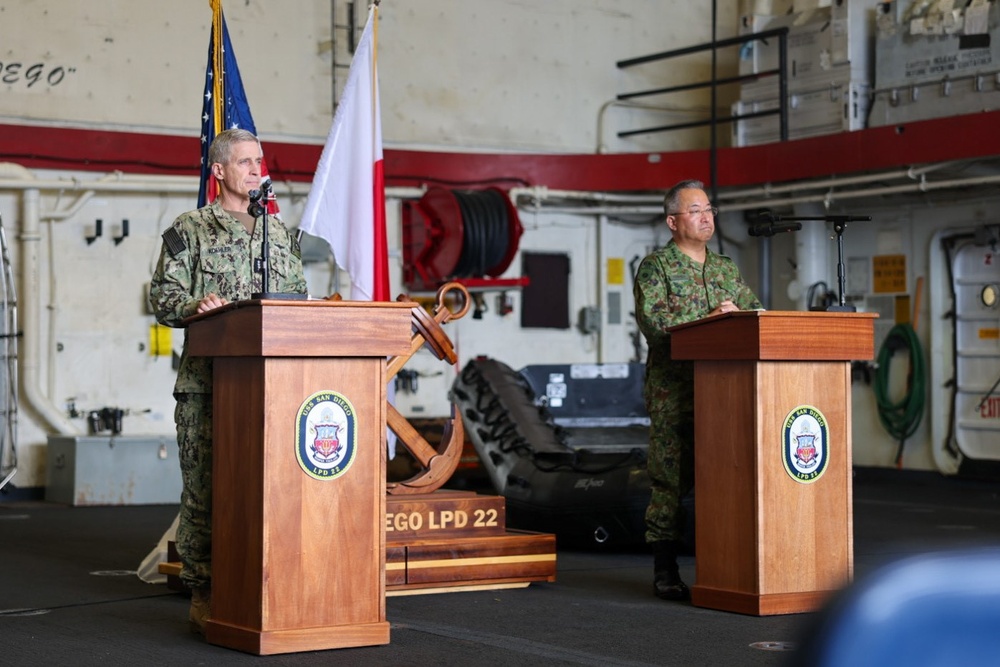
[295,391,358,480]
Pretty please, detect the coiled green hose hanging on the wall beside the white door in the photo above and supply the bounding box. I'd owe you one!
[873,323,927,466]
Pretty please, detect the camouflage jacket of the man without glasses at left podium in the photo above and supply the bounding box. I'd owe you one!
[149,201,306,393]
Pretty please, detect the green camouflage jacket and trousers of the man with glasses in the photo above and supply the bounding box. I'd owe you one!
[634,241,761,543]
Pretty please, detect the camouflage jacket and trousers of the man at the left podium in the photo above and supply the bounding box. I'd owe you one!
[150,202,306,589]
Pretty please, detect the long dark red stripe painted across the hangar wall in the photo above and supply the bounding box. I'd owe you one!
[0,111,1000,191]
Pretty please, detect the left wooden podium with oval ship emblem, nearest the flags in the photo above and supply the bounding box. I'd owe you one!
[188,300,411,655]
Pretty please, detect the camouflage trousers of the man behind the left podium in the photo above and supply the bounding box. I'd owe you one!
[174,394,212,588]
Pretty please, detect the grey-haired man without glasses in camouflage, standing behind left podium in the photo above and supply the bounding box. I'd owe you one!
[150,130,306,632]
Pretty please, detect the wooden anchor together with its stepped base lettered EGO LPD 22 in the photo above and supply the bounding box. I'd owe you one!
[385,282,556,595]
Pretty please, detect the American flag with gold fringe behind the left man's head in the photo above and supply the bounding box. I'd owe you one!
[198,0,278,214]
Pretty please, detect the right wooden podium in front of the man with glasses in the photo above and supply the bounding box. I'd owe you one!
[671,311,876,616]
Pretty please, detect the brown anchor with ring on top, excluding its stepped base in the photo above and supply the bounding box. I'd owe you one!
[386,282,471,495]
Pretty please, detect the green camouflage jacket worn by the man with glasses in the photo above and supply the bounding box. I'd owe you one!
[633,241,761,384]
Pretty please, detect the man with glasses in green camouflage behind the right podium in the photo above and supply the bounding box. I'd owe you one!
[634,181,761,600]
